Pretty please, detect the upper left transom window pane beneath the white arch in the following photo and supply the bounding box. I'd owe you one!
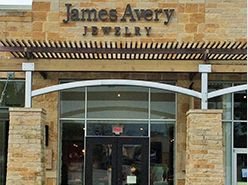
[60,88,85,118]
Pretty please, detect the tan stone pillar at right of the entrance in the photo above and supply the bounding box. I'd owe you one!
[185,110,224,185]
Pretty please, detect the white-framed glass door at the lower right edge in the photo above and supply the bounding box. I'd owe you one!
[234,151,247,185]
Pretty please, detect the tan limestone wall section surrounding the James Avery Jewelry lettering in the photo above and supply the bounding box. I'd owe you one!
[0,0,247,42]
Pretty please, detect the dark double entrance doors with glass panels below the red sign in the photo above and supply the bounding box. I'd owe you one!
[85,137,149,185]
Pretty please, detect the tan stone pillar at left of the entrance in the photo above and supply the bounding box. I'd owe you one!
[6,108,45,185]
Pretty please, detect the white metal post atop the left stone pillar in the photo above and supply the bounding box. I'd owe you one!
[22,63,34,108]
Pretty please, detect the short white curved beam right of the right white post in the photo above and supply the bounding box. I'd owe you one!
[208,84,247,99]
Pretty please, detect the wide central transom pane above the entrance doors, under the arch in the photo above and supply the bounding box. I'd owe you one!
[87,86,148,119]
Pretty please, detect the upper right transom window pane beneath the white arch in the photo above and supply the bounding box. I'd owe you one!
[151,89,176,119]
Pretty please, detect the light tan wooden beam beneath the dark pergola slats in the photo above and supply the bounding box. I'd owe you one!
[0,59,247,73]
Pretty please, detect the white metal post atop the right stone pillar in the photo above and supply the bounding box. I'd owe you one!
[199,64,211,109]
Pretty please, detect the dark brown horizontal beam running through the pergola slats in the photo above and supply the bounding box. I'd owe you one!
[0,46,247,55]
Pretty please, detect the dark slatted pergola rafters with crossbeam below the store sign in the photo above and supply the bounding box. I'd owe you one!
[0,40,247,61]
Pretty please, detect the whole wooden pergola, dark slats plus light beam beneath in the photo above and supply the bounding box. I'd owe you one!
[0,39,247,78]
